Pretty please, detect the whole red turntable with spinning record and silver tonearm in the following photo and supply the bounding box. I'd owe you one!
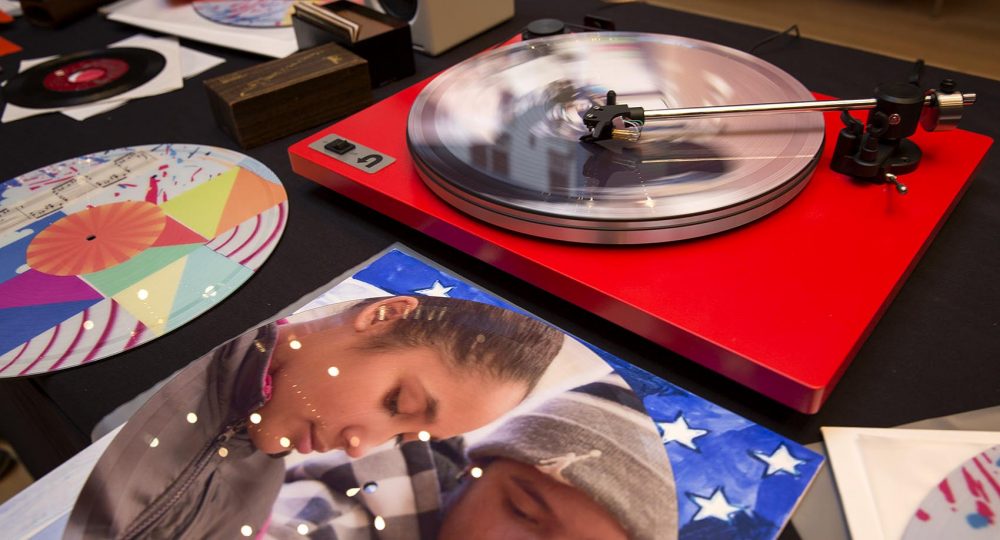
[289,33,992,413]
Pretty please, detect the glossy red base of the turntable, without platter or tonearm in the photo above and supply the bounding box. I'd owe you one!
[289,78,992,413]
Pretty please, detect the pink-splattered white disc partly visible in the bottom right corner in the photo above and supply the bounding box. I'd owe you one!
[903,446,1000,540]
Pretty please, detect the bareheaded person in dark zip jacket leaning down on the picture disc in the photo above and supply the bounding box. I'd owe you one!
[65,296,565,539]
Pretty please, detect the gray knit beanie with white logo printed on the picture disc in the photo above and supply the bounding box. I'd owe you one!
[469,375,677,540]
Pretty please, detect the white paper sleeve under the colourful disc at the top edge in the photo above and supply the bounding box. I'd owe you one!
[108,0,299,58]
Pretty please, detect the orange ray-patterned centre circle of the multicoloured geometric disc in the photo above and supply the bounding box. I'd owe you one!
[27,201,166,276]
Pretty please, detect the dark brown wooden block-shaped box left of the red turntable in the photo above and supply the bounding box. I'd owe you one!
[205,43,372,148]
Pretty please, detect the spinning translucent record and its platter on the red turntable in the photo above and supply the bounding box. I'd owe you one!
[407,32,824,244]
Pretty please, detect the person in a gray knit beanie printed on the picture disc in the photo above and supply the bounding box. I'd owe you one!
[439,375,678,540]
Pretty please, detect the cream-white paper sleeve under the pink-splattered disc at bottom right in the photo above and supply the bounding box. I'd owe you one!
[822,427,1000,540]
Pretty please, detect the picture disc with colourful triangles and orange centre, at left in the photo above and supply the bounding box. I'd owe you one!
[0,144,288,377]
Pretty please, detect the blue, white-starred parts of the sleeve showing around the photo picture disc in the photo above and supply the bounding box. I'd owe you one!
[353,249,823,540]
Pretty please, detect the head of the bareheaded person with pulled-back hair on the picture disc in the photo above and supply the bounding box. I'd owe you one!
[250,296,563,457]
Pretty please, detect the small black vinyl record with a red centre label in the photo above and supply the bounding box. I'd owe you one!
[2,47,167,109]
